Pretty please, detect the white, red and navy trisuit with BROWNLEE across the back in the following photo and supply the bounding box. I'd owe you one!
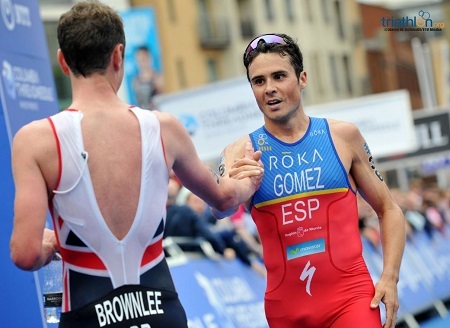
[49,107,187,328]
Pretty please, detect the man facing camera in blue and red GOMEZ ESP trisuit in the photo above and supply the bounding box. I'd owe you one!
[216,34,405,328]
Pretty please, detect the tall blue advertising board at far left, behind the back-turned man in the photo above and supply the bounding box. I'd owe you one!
[0,0,58,327]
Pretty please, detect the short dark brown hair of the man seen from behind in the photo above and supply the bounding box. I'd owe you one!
[57,0,125,77]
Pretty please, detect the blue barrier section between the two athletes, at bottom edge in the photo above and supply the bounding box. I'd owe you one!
[171,258,268,328]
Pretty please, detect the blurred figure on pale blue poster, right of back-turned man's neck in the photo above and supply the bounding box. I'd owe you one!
[132,46,163,110]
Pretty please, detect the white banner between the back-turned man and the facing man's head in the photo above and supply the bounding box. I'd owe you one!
[155,77,264,161]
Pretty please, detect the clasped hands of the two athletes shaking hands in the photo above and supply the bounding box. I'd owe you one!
[229,142,264,180]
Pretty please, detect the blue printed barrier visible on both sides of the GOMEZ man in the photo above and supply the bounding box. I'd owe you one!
[171,228,450,328]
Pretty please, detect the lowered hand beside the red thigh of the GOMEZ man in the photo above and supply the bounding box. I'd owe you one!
[370,277,399,328]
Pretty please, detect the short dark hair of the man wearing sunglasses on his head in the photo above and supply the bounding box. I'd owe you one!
[244,33,303,81]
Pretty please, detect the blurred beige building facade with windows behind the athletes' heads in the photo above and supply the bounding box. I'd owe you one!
[40,0,371,107]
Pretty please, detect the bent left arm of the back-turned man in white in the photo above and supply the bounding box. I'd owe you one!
[10,120,57,271]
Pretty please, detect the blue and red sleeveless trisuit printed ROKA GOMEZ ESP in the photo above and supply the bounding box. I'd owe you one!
[250,118,381,328]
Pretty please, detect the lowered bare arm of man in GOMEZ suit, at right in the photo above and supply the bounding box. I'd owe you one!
[345,125,405,328]
